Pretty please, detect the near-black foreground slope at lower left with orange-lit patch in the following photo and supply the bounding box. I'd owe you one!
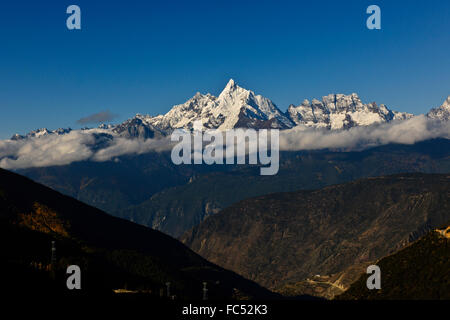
[0,169,274,299]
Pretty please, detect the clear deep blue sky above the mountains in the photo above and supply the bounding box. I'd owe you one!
[0,0,450,139]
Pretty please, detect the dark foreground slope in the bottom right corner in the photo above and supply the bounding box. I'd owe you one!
[337,224,450,300]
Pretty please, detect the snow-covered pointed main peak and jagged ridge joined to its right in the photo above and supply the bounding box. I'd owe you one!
[130,84,413,131]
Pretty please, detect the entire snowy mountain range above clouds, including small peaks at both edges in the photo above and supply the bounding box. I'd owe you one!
[11,79,450,140]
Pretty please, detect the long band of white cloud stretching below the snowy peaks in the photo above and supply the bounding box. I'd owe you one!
[0,116,450,169]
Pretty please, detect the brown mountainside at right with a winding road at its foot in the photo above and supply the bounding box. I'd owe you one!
[182,174,450,298]
